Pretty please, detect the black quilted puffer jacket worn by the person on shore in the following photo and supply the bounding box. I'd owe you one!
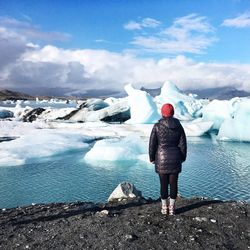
[149,117,187,174]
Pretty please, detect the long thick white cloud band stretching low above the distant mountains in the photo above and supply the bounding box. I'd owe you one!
[0,46,250,92]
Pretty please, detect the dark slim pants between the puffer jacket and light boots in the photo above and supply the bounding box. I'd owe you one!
[159,173,178,199]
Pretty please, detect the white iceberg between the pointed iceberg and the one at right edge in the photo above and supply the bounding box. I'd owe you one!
[202,97,240,130]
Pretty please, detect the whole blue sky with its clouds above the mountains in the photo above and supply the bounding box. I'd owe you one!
[0,0,250,94]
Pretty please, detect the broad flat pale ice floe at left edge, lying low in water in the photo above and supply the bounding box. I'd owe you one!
[0,127,89,166]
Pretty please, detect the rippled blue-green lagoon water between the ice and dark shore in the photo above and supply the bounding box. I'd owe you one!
[0,138,250,208]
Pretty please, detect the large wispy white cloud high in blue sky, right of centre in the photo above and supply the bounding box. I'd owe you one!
[131,14,217,54]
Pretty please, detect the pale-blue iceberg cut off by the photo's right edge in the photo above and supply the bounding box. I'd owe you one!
[217,98,250,142]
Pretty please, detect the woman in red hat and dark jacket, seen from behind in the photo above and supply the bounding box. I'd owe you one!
[149,103,187,215]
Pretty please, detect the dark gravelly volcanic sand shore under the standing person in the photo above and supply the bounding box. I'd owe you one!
[0,198,250,250]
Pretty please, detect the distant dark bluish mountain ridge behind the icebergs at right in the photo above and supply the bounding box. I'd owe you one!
[188,87,250,100]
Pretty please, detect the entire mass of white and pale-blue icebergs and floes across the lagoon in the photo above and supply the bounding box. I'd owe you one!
[0,82,250,166]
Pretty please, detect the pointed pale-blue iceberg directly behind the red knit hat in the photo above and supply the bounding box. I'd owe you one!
[155,81,207,120]
